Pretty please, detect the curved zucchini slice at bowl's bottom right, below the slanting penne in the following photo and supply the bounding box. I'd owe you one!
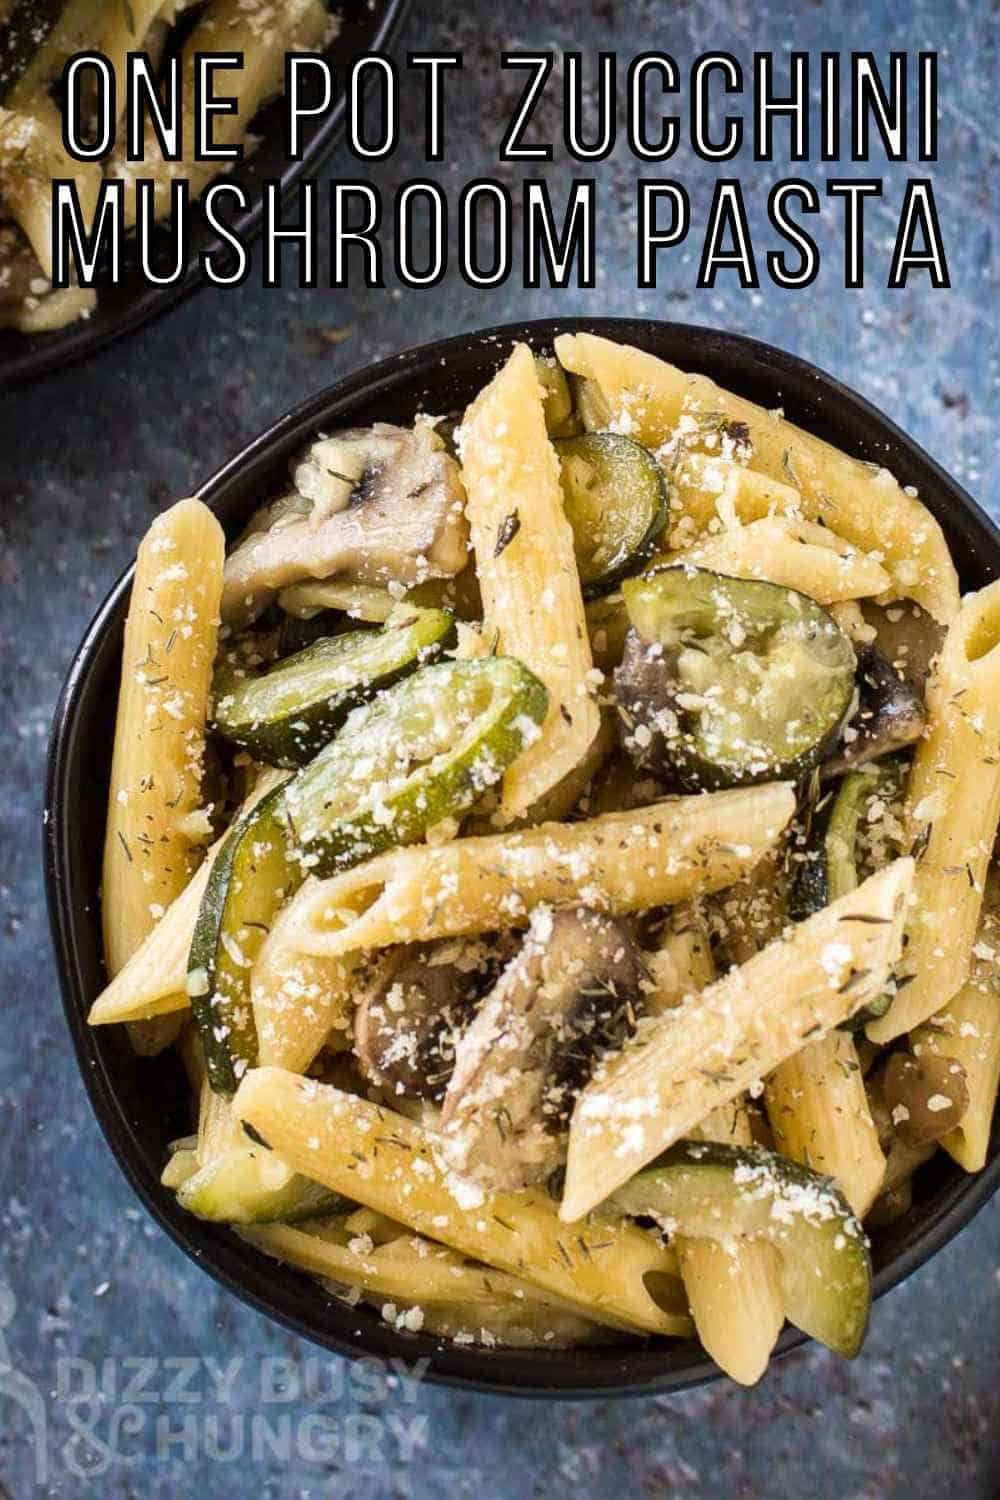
[604,1140,871,1359]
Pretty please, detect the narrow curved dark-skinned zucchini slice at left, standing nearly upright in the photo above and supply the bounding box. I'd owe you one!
[187,783,296,1095]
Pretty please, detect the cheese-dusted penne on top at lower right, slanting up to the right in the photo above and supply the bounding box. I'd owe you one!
[559,860,913,1223]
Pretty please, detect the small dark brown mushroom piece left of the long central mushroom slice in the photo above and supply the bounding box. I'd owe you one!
[354,933,517,1100]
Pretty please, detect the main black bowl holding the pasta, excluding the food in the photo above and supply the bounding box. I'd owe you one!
[45,318,1000,1397]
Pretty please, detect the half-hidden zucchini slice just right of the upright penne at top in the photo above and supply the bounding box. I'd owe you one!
[553,432,667,599]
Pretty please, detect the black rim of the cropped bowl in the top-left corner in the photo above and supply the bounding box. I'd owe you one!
[0,0,409,390]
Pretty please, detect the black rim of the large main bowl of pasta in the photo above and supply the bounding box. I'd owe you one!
[43,317,1000,1400]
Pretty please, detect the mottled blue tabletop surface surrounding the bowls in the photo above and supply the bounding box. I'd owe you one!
[0,0,1000,1500]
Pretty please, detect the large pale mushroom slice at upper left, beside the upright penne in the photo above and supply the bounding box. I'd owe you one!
[222,422,468,624]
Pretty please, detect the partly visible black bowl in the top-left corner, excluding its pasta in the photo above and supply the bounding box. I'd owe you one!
[0,0,406,390]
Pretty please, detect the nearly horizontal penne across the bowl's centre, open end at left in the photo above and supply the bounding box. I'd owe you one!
[269,782,795,957]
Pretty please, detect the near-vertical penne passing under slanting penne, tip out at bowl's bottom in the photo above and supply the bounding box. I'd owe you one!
[646,905,784,1386]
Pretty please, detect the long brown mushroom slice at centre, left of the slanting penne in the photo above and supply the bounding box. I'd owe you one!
[441,908,642,1188]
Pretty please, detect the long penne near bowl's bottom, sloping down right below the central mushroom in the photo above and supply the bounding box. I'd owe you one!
[232,1068,691,1337]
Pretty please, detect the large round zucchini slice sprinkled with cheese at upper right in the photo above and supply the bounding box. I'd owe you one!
[615,566,856,791]
